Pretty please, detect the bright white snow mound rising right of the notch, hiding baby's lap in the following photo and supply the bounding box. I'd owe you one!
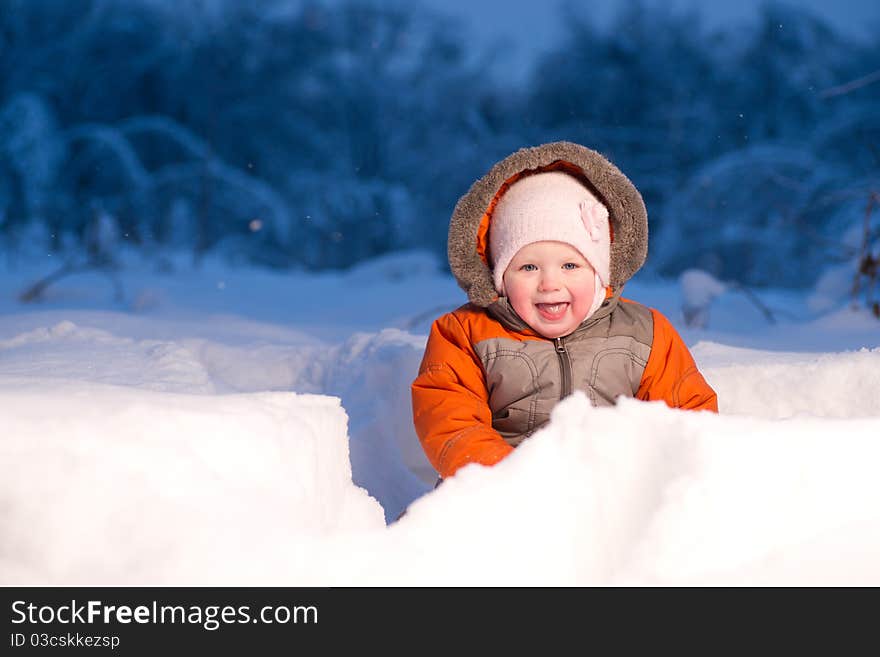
[384,393,880,586]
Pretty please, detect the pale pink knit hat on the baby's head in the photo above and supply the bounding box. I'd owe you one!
[489,171,611,295]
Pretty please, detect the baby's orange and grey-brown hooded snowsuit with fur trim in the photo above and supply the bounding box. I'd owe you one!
[412,142,718,478]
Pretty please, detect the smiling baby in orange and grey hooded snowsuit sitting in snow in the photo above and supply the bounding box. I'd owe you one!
[412,142,718,478]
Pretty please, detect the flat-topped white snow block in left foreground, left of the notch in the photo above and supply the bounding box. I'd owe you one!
[0,378,385,584]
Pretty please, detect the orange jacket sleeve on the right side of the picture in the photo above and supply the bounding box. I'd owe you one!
[636,308,718,413]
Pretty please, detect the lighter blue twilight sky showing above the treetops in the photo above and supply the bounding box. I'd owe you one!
[416,0,880,80]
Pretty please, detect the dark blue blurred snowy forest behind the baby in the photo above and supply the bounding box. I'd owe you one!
[0,0,880,287]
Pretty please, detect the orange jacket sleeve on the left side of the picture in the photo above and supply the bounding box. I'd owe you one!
[412,313,513,479]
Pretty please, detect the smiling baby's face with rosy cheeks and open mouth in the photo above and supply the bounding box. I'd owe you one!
[504,242,596,338]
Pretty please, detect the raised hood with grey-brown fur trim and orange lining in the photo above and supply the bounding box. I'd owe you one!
[447,141,648,308]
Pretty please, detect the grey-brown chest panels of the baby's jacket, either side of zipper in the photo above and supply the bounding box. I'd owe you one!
[474,299,654,447]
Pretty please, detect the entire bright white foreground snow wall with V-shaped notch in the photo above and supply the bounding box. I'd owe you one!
[8,385,880,586]
